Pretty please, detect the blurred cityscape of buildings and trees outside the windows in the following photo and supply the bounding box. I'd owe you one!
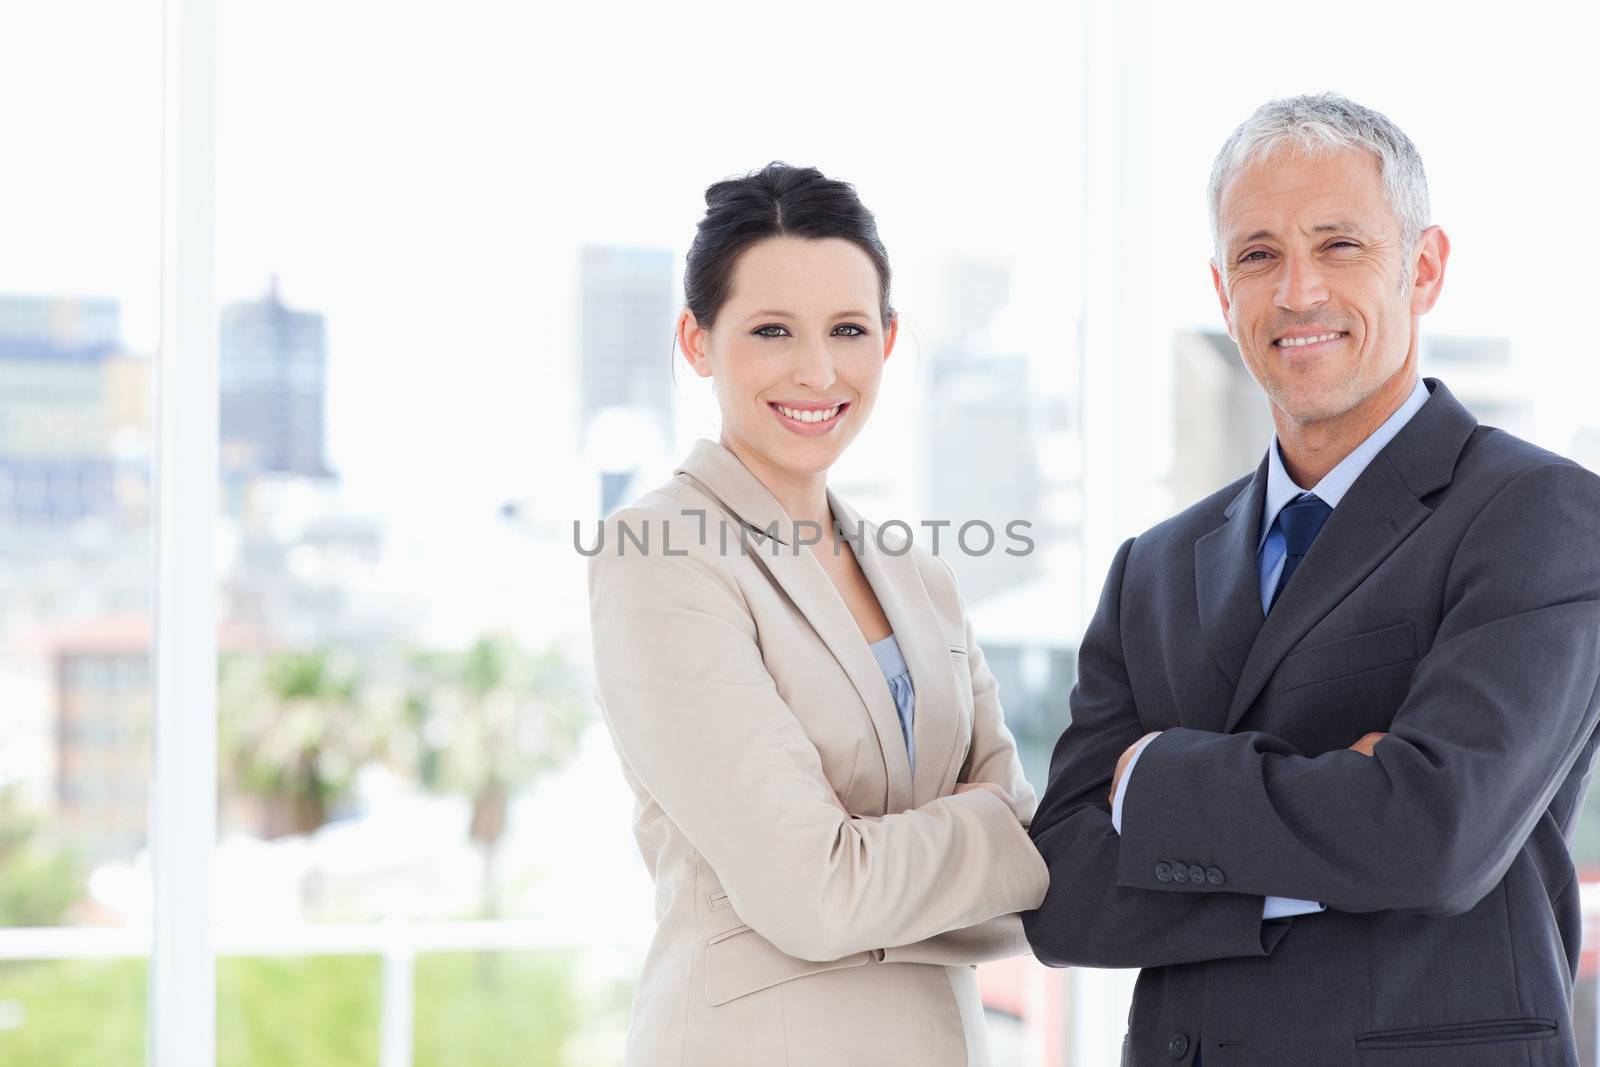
[9,245,1600,1062]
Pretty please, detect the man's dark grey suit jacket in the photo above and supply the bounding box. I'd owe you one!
[1024,379,1600,1067]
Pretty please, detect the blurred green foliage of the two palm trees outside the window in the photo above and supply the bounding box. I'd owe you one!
[218,633,586,849]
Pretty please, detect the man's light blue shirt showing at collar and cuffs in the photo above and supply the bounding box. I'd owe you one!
[1110,378,1432,918]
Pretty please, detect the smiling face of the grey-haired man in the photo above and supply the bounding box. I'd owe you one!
[1211,150,1448,424]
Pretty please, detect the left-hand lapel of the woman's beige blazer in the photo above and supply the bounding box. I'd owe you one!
[678,440,917,811]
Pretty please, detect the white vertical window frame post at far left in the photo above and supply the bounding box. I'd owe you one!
[146,0,219,1067]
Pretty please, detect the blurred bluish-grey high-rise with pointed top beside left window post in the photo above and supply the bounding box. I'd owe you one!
[219,280,331,478]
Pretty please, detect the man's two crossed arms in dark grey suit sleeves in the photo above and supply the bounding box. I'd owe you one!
[1024,464,1600,966]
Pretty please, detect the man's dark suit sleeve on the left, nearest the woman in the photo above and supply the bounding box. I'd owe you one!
[1022,541,1286,966]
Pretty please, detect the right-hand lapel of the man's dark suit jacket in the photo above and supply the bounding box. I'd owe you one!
[1224,379,1477,731]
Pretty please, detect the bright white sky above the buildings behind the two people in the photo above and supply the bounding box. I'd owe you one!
[0,0,1600,643]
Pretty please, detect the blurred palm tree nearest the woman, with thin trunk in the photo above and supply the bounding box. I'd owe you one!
[403,633,586,917]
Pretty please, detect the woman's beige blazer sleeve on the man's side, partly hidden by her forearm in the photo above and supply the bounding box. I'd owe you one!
[883,557,1035,965]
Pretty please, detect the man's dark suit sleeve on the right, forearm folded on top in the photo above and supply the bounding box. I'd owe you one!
[1118,462,1600,915]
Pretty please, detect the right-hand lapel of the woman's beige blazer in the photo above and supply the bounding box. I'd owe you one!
[827,491,960,806]
